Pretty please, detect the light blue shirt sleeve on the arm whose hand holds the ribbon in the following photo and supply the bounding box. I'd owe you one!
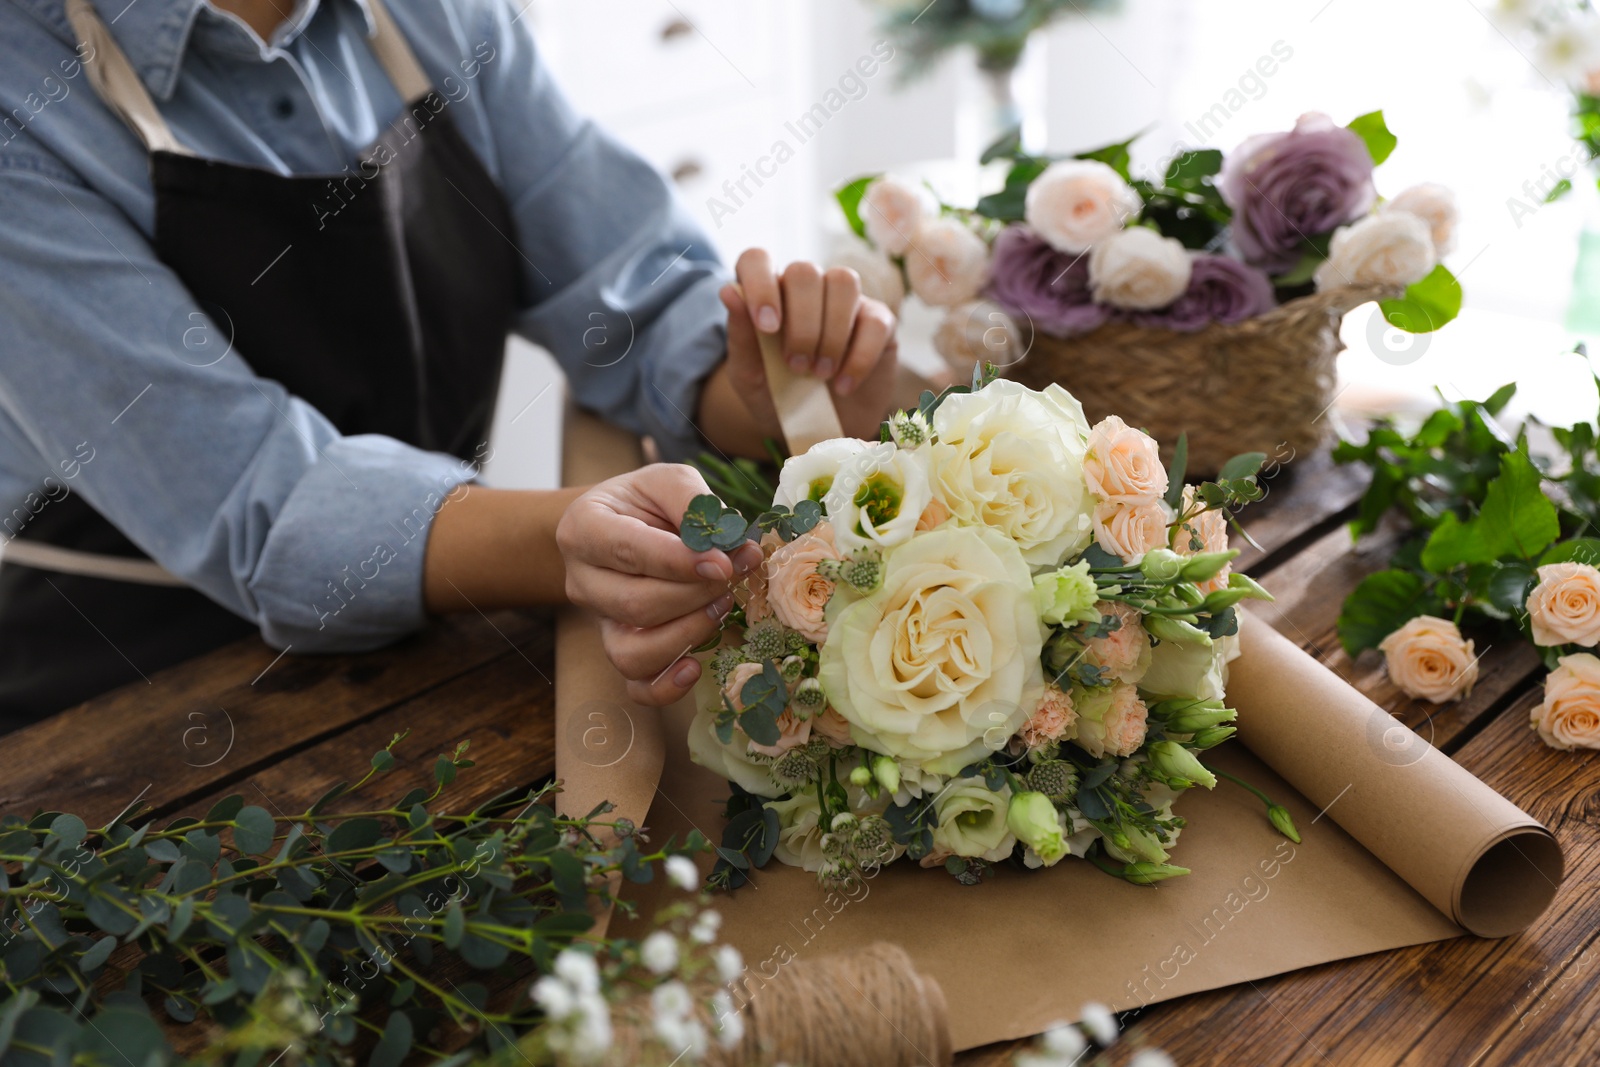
[464,0,728,459]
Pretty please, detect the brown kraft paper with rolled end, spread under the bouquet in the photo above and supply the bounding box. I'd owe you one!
[557,412,1562,1049]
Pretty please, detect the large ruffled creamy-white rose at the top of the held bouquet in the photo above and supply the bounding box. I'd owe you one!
[928,378,1094,566]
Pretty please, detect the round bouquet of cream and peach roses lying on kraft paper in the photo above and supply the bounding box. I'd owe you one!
[682,375,1298,888]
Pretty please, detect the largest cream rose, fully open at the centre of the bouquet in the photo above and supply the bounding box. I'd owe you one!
[818,526,1045,774]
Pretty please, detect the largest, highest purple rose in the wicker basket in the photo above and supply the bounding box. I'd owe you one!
[1216,112,1378,274]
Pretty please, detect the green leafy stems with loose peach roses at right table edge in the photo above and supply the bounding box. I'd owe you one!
[1333,374,1600,749]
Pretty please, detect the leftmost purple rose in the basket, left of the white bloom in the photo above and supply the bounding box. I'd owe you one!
[989,226,1110,338]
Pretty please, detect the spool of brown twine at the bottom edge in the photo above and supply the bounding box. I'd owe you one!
[605,941,954,1067]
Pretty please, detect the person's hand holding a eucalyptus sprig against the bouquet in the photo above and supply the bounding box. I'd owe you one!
[555,464,762,705]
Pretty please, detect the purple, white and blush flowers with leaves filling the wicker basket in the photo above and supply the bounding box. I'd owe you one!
[835,112,1461,363]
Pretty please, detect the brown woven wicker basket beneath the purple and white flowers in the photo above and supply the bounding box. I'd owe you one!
[1002,288,1392,475]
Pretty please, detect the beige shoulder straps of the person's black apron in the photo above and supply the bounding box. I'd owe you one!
[66,0,434,155]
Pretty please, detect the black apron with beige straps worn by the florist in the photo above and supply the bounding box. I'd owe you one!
[0,0,525,733]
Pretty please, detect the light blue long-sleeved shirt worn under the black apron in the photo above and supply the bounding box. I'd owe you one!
[0,0,726,653]
